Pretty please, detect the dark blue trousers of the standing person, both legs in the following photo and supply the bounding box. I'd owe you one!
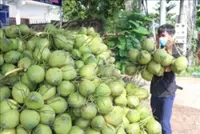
[151,96,175,134]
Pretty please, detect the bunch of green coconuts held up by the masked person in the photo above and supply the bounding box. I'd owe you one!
[126,38,188,81]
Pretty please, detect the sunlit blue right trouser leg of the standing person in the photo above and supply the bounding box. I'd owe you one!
[160,96,175,134]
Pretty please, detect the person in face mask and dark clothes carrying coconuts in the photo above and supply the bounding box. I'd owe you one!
[150,24,178,134]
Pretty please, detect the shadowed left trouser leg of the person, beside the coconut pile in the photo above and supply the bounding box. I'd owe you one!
[151,96,162,122]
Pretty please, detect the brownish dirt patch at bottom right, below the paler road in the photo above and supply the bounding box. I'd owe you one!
[171,104,200,134]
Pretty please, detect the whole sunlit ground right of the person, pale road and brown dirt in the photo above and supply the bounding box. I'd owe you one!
[164,77,200,134]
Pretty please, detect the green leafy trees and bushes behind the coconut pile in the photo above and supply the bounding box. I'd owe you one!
[60,0,200,73]
